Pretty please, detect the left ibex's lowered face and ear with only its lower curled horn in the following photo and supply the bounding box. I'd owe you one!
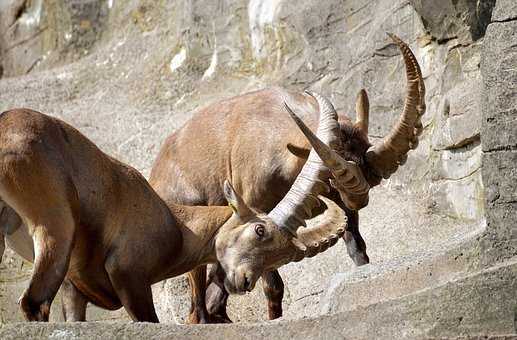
[216,186,346,293]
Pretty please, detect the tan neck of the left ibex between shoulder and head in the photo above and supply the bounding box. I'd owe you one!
[168,204,232,276]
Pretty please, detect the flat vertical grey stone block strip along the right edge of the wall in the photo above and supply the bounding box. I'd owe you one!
[482,0,517,263]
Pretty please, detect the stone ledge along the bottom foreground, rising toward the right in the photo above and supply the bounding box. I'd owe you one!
[0,258,517,340]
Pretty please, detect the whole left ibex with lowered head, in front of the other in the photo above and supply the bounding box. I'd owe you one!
[0,90,346,322]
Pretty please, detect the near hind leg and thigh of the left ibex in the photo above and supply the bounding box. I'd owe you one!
[0,160,78,321]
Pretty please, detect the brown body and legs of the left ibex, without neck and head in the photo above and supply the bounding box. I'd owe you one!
[0,109,182,321]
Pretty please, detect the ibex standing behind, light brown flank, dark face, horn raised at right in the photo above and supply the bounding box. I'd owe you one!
[150,35,425,323]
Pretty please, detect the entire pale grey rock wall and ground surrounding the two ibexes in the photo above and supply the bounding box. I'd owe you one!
[0,0,517,338]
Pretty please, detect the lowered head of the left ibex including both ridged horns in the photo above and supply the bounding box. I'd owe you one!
[215,94,346,293]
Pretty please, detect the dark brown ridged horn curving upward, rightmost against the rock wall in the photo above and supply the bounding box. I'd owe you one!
[366,33,425,178]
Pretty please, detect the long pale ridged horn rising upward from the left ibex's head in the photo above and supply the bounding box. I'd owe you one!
[268,93,340,237]
